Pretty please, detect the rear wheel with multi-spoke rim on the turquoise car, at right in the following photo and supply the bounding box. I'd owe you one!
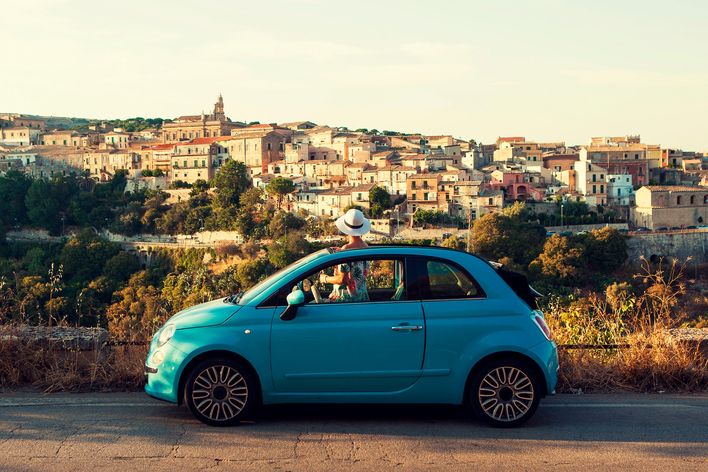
[469,359,542,428]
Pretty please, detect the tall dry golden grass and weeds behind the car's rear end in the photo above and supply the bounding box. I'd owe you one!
[545,261,708,392]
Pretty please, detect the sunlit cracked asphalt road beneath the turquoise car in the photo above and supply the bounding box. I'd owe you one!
[0,393,708,472]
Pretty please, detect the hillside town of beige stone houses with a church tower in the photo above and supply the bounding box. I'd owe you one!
[0,95,708,231]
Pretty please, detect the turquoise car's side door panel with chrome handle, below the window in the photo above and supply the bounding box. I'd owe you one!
[271,258,425,393]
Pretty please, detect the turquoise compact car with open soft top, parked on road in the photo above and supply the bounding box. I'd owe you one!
[145,246,558,426]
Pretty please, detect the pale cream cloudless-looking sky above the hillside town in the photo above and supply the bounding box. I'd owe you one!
[0,0,708,152]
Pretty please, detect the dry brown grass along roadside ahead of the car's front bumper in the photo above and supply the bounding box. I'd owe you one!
[0,341,147,393]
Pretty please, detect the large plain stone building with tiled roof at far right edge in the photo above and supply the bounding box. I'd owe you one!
[630,185,708,229]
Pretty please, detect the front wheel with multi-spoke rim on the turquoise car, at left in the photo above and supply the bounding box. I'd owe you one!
[184,358,258,426]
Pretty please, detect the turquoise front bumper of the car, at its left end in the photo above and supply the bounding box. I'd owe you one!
[145,342,187,403]
